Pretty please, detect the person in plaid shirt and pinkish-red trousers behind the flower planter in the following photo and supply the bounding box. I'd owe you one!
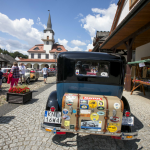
[10,62,20,88]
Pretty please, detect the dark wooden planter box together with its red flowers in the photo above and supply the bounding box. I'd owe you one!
[7,85,32,104]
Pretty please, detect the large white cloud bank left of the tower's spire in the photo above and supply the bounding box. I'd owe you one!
[0,13,43,47]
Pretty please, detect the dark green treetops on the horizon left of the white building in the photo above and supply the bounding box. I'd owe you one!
[0,48,28,59]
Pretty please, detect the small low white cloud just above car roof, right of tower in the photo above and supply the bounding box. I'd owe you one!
[58,38,82,51]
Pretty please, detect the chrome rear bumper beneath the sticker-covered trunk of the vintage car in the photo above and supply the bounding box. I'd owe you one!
[41,123,138,140]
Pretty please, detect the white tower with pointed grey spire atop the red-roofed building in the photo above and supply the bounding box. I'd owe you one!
[42,13,55,54]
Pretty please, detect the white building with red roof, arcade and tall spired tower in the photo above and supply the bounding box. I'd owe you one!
[16,14,67,69]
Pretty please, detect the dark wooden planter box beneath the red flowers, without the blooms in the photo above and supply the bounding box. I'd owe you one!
[7,91,32,104]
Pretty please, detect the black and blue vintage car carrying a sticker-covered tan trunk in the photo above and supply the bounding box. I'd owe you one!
[41,52,138,140]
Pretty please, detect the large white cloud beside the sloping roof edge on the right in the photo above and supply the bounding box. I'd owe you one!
[80,4,117,37]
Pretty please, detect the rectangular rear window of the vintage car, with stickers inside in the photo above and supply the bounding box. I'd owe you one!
[75,61,110,77]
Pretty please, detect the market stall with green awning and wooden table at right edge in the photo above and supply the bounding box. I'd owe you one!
[128,59,150,95]
